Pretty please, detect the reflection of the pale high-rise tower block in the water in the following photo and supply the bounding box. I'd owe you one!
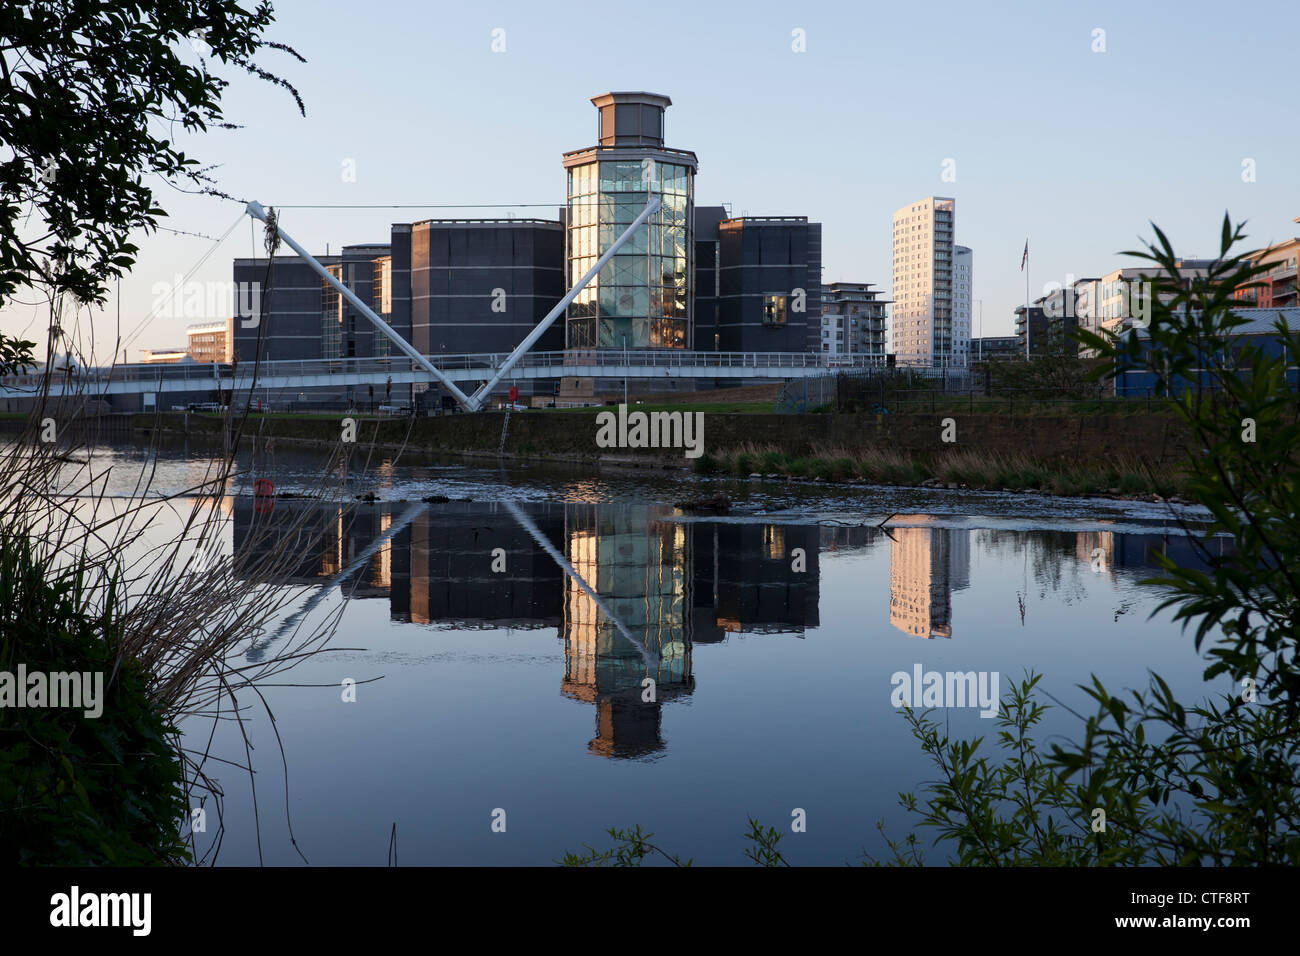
[889,528,971,639]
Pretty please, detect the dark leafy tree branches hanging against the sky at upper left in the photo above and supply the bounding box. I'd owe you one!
[0,0,303,304]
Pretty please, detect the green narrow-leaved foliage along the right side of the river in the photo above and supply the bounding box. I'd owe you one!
[889,216,1300,866]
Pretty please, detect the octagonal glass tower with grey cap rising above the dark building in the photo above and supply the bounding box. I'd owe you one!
[564,92,698,349]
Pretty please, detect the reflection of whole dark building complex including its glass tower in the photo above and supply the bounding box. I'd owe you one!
[234,498,826,757]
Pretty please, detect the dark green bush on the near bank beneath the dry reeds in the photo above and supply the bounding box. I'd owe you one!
[0,528,189,866]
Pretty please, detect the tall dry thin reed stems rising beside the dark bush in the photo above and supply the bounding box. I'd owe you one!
[0,286,410,864]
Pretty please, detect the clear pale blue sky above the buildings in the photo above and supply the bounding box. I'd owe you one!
[0,0,1300,360]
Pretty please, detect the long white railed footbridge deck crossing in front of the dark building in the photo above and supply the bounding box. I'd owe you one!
[0,349,904,398]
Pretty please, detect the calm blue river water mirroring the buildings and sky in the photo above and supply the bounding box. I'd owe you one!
[76,446,1231,865]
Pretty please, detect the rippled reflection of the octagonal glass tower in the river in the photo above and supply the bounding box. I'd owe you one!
[560,505,694,757]
